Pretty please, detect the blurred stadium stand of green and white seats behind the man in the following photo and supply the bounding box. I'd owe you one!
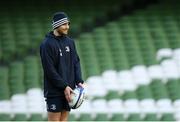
[0,0,180,121]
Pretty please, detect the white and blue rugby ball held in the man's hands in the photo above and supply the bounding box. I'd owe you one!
[69,87,85,109]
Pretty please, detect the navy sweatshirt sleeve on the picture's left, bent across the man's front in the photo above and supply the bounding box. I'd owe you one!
[40,44,68,90]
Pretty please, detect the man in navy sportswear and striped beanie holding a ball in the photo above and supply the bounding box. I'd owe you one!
[40,12,84,121]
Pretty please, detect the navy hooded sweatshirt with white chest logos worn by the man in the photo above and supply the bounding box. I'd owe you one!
[40,32,84,98]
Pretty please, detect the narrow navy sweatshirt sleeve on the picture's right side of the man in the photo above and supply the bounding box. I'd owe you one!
[73,42,84,84]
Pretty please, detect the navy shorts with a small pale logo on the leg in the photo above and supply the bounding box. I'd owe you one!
[46,97,71,112]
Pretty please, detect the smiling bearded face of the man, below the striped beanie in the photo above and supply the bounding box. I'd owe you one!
[57,23,69,35]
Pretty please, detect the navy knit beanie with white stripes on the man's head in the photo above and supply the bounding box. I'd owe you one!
[52,12,69,29]
